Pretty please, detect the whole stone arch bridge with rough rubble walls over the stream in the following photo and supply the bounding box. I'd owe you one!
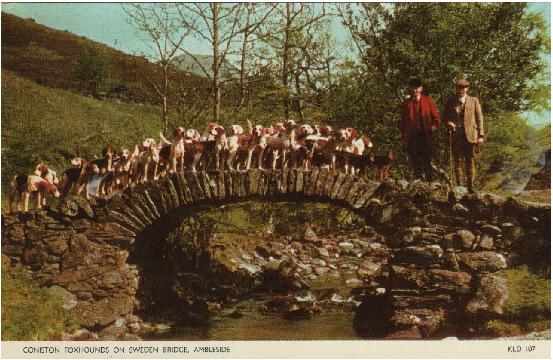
[2,168,551,339]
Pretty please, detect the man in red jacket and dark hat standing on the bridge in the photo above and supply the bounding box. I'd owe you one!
[401,79,441,181]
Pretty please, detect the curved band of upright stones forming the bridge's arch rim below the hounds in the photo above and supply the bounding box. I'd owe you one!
[89,168,380,233]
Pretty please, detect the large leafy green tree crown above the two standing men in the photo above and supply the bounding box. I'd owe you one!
[338,3,549,111]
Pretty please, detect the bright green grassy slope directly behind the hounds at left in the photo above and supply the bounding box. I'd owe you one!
[2,70,163,191]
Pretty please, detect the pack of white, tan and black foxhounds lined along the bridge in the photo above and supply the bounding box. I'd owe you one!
[10,120,395,212]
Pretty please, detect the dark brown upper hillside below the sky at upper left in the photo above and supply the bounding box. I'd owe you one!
[2,12,209,102]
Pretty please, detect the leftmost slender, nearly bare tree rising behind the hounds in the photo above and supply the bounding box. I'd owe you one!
[123,3,191,131]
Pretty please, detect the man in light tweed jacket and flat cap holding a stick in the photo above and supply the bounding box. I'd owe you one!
[444,79,484,193]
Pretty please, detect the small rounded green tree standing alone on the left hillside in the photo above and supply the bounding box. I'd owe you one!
[75,46,112,96]
